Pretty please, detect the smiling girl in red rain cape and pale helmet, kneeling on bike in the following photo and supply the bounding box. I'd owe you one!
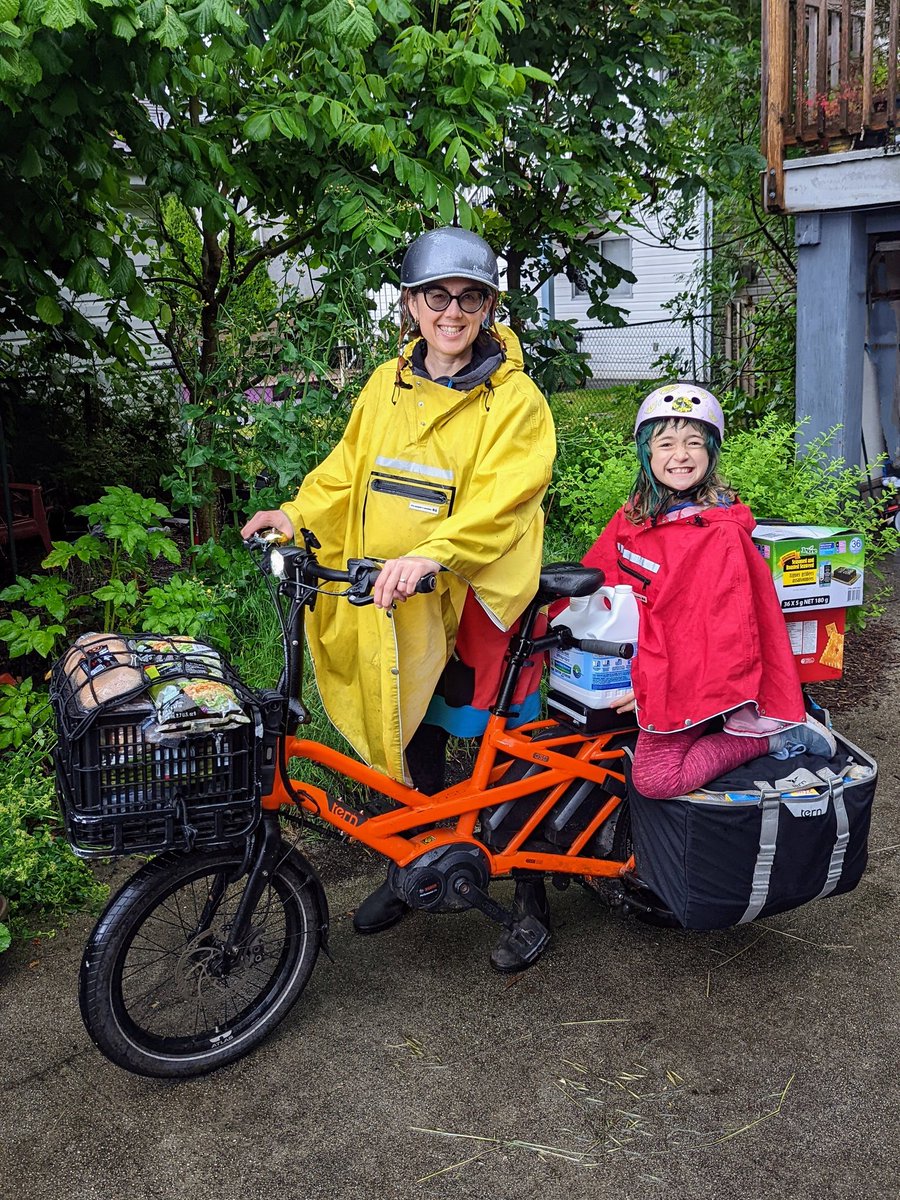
[583,383,835,799]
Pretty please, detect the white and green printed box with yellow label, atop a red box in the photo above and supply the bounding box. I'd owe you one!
[754,523,865,613]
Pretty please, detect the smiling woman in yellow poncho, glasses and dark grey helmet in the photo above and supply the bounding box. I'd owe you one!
[242,228,556,965]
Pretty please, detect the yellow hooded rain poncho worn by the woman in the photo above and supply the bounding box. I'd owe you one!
[282,328,556,779]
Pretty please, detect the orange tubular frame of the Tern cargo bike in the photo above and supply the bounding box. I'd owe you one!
[256,544,634,878]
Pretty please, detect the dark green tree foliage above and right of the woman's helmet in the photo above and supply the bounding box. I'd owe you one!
[480,0,728,314]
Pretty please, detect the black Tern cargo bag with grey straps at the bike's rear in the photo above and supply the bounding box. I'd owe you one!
[629,737,877,929]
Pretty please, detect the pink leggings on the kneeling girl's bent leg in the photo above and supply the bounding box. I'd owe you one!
[631,721,769,800]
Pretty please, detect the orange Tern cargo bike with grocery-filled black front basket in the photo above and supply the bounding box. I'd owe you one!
[52,534,640,1076]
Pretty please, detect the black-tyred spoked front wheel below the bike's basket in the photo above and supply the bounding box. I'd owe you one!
[79,841,328,1078]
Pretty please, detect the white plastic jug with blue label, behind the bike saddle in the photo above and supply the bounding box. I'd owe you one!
[547,583,638,726]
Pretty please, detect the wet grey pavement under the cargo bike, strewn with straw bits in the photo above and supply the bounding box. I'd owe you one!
[0,573,900,1200]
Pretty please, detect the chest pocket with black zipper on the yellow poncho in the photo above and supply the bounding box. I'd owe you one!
[362,470,456,558]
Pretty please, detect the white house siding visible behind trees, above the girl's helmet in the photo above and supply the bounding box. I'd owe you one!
[552,203,709,382]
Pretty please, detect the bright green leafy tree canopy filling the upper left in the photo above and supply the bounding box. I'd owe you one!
[0,0,535,360]
